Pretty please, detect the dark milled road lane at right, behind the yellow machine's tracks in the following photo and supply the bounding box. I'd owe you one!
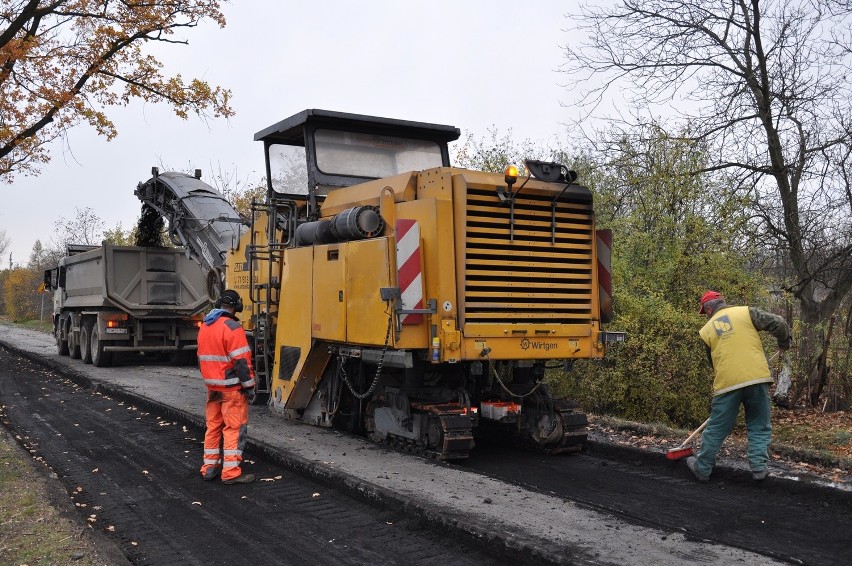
[464,445,852,566]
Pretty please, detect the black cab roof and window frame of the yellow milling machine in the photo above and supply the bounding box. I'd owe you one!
[254,109,461,199]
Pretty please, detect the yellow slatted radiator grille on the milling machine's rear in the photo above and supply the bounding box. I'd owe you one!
[464,188,594,324]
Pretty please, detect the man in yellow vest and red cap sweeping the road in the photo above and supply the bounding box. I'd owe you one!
[686,291,792,481]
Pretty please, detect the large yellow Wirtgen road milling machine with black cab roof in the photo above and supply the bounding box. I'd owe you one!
[138,109,624,460]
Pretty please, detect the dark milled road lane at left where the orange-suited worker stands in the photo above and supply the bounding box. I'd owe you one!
[0,348,511,566]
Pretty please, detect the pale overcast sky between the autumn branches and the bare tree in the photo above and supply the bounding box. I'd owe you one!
[0,0,592,268]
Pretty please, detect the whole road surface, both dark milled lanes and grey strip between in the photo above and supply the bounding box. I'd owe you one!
[0,325,852,566]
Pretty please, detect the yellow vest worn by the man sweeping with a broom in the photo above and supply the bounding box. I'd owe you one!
[699,307,772,395]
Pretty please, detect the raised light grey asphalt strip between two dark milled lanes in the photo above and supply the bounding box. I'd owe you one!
[0,324,779,566]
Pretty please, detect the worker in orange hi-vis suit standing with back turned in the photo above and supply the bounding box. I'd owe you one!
[198,289,255,484]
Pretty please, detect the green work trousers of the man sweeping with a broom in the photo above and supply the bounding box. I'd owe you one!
[695,383,772,482]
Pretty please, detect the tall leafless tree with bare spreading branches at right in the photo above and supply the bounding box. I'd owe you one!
[563,0,852,404]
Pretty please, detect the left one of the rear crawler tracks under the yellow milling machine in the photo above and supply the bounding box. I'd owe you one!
[364,390,478,460]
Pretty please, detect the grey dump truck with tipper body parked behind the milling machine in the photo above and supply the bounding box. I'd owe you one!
[44,242,211,367]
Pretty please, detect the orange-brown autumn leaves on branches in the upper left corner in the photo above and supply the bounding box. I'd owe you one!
[0,0,233,182]
